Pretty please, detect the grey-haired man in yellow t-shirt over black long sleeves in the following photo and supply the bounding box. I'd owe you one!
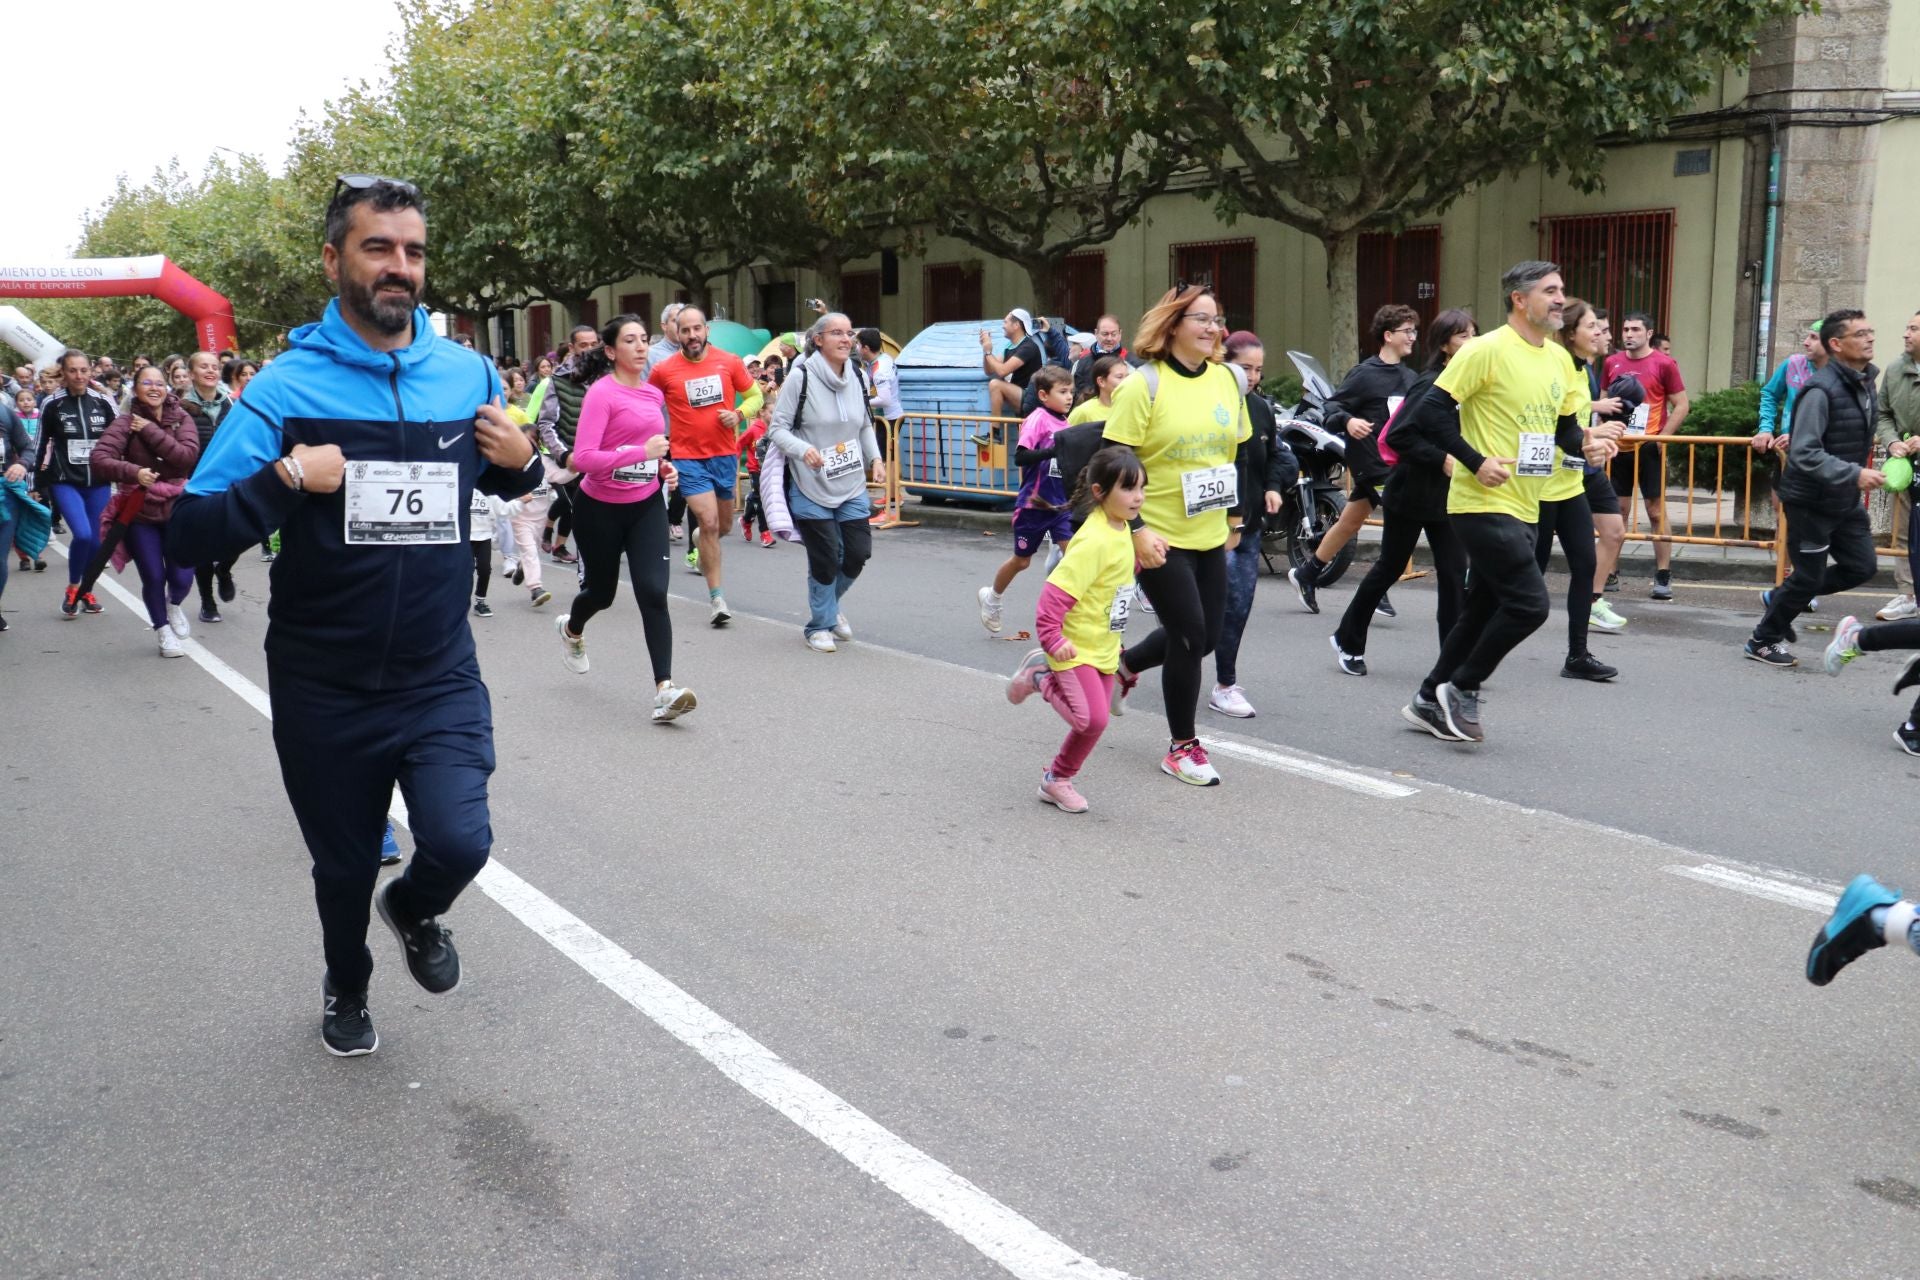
[1400,261,1615,743]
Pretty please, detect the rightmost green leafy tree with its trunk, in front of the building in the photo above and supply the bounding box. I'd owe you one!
[1121,0,1812,368]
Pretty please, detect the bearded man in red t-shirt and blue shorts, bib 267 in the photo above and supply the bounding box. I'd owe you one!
[647,307,760,628]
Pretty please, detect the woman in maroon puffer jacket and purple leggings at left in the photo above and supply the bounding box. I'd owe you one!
[90,368,200,658]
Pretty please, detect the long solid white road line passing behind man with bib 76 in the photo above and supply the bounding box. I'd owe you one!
[54,543,1133,1280]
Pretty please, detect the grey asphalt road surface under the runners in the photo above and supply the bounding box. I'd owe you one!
[0,530,1920,1280]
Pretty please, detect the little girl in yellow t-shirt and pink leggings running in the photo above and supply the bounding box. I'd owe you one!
[1006,445,1146,814]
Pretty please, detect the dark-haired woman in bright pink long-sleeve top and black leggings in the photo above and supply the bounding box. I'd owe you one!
[553,315,699,723]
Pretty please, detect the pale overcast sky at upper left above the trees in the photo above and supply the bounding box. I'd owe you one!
[12,0,399,263]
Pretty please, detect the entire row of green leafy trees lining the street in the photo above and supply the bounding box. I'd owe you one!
[11,0,1812,367]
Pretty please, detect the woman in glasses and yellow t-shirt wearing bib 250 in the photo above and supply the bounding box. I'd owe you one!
[1102,286,1254,787]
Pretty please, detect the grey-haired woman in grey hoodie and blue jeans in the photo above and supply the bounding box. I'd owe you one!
[768,311,887,652]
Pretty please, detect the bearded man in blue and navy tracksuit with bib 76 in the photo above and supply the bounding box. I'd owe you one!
[169,177,540,1057]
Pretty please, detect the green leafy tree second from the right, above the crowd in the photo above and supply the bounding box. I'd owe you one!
[707,0,1179,307]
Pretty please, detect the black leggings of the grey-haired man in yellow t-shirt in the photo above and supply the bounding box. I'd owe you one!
[1421,512,1551,699]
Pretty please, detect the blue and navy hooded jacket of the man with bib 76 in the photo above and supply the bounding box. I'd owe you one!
[169,299,541,691]
